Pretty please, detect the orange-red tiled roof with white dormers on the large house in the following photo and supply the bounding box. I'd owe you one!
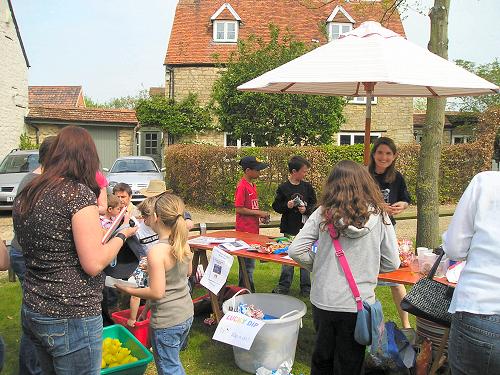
[165,0,405,65]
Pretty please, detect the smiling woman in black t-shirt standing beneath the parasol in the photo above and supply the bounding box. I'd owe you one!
[368,137,411,328]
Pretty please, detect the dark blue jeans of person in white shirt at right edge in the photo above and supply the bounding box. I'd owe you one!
[448,311,500,375]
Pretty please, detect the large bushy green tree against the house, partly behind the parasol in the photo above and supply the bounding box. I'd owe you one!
[212,25,345,146]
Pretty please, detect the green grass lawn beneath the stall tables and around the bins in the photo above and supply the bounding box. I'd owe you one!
[0,261,415,375]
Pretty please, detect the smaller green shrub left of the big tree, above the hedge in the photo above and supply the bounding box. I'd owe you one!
[135,94,213,137]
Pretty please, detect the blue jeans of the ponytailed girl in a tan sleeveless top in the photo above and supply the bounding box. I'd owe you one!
[150,317,193,375]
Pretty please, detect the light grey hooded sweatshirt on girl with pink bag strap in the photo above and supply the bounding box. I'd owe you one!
[288,207,400,312]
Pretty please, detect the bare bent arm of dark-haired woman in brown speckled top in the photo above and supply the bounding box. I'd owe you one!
[71,201,137,276]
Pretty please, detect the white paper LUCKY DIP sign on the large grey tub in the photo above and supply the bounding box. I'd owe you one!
[212,311,265,350]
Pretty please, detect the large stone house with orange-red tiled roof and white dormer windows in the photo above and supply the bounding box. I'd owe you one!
[164,0,414,146]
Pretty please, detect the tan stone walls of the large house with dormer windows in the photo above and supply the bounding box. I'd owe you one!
[170,67,414,145]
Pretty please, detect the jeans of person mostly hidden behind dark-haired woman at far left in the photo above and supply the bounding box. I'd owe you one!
[9,246,42,375]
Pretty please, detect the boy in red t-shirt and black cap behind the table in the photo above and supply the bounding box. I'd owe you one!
[234,156,269,292]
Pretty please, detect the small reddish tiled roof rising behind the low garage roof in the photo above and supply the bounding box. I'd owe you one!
[28,86,85,107]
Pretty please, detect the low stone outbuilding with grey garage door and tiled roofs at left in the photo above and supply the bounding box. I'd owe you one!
[25,86,138,168]
